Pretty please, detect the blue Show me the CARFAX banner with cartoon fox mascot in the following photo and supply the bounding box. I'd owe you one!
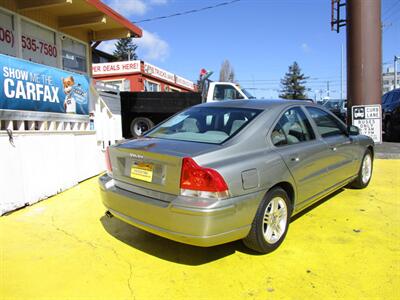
[0,54,89,115]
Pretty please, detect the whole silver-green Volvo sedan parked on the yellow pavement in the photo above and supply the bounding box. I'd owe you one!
[99,100,374,253]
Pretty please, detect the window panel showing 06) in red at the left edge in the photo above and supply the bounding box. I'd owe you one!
[0,10,17,56]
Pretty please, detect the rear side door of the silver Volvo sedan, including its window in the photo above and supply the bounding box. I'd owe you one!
[270,106,328,209]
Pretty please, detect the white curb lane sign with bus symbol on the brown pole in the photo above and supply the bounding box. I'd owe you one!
[351,104,382,143]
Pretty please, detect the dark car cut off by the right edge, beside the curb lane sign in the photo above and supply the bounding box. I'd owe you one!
[382,89,400,141]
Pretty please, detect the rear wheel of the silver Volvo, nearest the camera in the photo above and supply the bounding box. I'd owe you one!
[243,187,292,253]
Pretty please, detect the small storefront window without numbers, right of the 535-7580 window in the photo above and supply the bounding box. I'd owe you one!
[62,37,87,73]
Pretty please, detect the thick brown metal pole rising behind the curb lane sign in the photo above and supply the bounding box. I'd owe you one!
[346,0,382,124]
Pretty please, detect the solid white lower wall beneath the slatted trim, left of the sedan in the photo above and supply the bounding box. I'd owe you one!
[0,131,105,215]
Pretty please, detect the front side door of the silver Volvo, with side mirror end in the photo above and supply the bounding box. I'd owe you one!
[306,106,360,189]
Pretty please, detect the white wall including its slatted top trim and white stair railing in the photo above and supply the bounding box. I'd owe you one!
[0,85,122,216]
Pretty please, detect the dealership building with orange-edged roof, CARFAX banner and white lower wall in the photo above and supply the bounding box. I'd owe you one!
[0,0,143,215]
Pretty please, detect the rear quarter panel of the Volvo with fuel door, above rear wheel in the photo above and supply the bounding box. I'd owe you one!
[195,106,296,207]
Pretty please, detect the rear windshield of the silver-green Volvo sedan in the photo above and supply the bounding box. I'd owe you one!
[146,107,261,144]
